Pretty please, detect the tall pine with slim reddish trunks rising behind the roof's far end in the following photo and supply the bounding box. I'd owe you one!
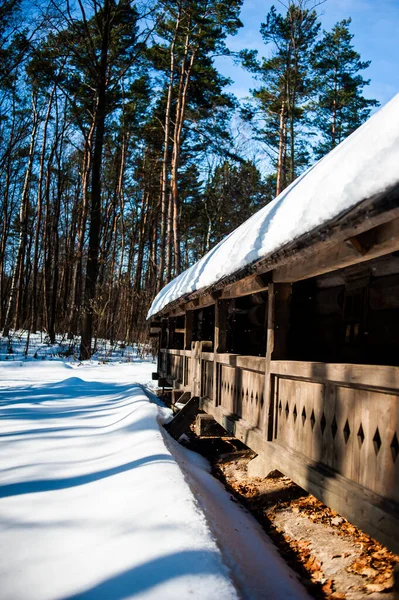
[152,0,242,288]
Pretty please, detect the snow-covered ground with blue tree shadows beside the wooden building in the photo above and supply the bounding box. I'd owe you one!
[0,360,307,600]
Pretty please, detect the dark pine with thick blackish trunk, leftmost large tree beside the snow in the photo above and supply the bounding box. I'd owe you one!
[44,0,142,359]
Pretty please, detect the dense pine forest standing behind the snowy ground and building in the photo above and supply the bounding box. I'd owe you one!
[0,0,390,359]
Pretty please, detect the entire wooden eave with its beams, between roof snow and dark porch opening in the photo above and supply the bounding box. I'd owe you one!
[150,184,399,320]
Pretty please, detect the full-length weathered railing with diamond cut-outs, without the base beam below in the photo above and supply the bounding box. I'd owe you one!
[161,350,399,502]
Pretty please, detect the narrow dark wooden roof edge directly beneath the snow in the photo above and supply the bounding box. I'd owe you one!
[149,184,399,321]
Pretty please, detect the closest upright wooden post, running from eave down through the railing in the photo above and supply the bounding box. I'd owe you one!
[263,283,291,441]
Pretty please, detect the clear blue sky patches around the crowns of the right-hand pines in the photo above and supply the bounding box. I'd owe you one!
[217,0,399,105]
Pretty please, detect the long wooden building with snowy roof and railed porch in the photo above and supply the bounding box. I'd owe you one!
[149,92,399,552]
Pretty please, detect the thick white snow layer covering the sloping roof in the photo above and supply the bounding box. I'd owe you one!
[147,94,399,318]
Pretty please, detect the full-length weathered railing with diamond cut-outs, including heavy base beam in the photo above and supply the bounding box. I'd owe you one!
[160,343,399,552]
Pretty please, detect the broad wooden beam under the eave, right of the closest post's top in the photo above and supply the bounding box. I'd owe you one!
[273,218,399,283]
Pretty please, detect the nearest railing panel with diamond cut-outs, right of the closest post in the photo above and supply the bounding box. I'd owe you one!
[270,361,399,502]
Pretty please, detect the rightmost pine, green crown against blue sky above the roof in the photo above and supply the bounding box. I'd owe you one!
[311,19,378,158]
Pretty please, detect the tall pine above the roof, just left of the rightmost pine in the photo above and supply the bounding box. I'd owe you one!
[241,0,320,195]
